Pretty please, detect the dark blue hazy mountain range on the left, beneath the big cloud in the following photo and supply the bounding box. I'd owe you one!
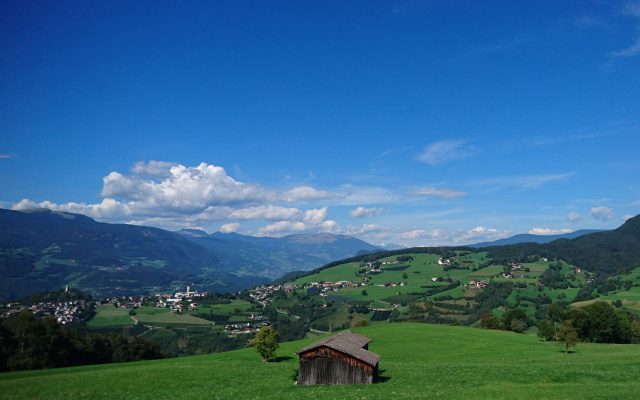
[0,209,379,301]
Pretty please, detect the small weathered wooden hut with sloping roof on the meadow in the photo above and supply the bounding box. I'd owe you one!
[298,331,380,385]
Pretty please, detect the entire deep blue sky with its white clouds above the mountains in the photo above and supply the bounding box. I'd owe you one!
[0,1,640,245]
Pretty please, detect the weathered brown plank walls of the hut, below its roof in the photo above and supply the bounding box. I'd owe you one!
[298,348,378,385]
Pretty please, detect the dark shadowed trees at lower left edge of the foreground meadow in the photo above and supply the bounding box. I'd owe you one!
[0,310,164,371]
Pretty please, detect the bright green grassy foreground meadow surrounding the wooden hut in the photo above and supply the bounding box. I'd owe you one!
[0,323,640,399]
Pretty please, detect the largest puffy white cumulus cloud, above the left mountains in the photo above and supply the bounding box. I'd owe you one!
[13,161,339,232]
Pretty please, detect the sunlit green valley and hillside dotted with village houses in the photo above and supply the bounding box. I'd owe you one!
[2,251,593,336]
